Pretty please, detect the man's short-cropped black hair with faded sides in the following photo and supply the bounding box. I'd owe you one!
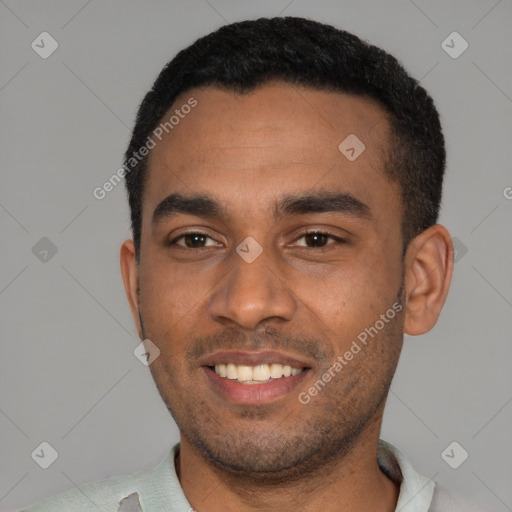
[124,17,446,260]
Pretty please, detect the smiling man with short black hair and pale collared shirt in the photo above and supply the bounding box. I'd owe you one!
[24,18,480,512]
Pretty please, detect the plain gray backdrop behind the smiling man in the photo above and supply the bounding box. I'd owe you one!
[0,0,512,511]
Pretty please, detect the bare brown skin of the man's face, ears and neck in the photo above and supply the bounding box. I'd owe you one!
[121,82,453,512]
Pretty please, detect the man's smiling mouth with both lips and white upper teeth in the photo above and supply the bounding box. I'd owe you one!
[202,351,311,404]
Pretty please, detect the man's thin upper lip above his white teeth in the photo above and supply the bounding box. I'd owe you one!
[200,350,311,368]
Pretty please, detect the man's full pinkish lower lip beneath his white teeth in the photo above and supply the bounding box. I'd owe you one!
[203,366,308,404]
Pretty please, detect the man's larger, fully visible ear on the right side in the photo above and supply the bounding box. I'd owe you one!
[404,224,454,336]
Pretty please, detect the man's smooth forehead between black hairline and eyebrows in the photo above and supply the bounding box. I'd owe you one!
[144,83,396,222]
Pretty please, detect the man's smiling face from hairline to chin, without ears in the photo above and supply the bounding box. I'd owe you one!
[134,83,403,473]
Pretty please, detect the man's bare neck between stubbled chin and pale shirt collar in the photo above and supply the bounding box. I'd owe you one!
[176,422,399,512]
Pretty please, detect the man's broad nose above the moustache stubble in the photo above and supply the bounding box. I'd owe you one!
[209,245,297,330]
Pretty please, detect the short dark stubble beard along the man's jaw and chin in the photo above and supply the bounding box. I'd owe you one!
[141,284,404,486]
